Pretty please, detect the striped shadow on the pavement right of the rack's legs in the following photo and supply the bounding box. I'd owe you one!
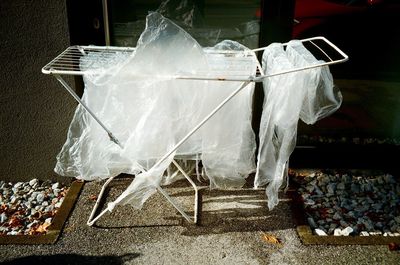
[180,190,295,236]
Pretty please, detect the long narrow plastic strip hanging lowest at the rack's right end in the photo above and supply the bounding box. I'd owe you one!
[254,43,304,209]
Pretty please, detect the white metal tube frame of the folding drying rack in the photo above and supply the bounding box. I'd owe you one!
[42,36,348,226]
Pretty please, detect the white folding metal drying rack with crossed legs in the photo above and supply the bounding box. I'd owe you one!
[42,37,348,226]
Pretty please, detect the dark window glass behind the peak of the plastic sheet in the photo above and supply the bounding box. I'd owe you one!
[109,0,260,48]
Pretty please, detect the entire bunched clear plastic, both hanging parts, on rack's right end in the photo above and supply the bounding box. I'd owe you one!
[254,40,342,209]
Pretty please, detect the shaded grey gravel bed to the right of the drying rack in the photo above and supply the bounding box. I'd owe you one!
[295,172,400,236]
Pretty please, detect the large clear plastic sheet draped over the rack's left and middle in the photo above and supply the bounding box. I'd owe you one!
[55,13,257,210]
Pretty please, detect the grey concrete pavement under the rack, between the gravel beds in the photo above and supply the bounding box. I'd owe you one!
[0,176,400,265]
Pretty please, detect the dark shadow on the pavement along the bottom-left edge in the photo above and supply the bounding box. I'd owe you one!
[2,253,140,265]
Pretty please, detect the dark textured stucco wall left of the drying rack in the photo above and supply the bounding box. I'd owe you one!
[0,0,76,181]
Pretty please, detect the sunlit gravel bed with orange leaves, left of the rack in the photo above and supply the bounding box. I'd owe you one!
[0,179,68,236]
